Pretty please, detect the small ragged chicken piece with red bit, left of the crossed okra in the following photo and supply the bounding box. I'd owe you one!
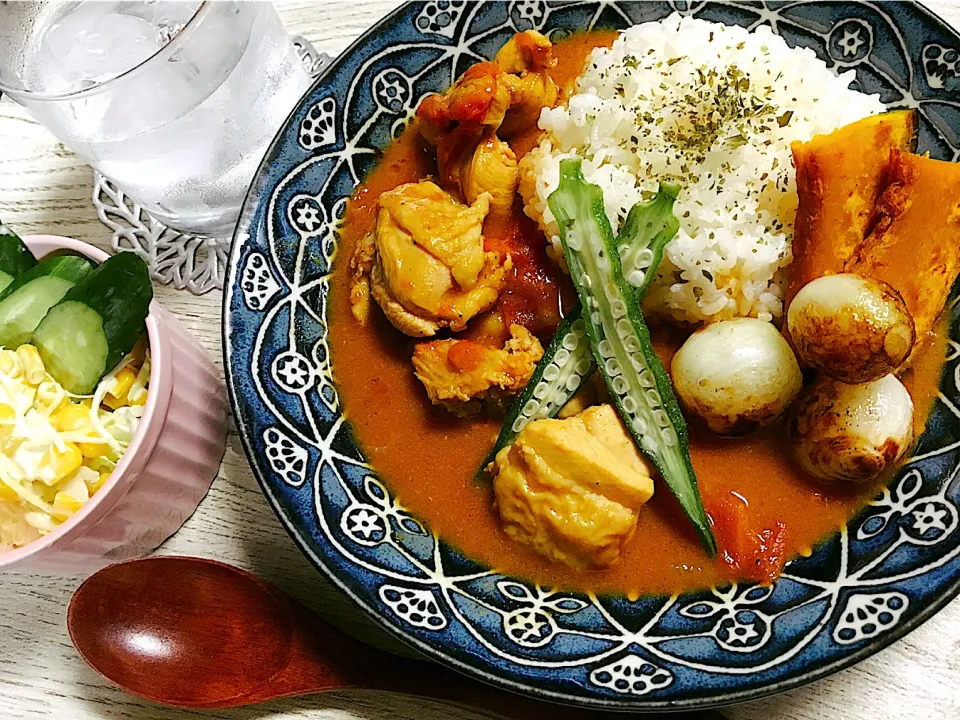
[413,325,543,417]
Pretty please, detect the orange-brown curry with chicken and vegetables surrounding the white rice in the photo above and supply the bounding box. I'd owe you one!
[329,23,960,598]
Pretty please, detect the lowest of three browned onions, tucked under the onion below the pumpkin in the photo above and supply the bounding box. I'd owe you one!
[788,375,913,484]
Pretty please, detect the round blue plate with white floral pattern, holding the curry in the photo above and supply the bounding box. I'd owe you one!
[224,0,960,709]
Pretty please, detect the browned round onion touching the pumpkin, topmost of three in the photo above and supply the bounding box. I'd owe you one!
[787,273,916,384]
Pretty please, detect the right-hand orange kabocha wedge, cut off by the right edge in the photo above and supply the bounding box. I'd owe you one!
[844,150,960,338]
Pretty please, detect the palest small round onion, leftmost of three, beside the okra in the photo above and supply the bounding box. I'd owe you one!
[671,318,803,435]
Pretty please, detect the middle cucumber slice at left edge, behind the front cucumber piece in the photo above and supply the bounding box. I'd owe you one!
[0,255,93,348]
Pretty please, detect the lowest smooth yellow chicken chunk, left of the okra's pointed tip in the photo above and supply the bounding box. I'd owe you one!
[493,405,653,569]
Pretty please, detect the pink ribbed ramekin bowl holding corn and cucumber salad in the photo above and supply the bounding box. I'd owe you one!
[0,235,227,575]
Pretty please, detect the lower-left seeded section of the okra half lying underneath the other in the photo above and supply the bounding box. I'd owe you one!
[477,305,597,476]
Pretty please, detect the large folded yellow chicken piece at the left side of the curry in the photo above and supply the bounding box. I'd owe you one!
[350,182,513,337]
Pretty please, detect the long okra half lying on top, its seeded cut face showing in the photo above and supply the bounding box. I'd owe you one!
[548,159,716,556]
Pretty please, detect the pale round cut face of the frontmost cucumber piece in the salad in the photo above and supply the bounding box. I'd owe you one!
[33,300,110,395]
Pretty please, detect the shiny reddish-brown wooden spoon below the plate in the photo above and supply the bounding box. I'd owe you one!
[67,557,724,720]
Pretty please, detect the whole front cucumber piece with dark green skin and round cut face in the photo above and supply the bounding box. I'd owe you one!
[33,252,153,395]
